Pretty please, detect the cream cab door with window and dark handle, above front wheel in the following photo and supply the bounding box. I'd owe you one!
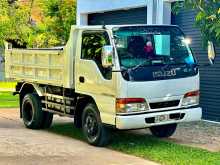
[76,30,116,124]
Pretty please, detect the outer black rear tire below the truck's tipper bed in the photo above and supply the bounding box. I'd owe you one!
[22,94,44,129]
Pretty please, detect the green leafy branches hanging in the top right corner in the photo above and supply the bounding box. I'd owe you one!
[173,0,220,45]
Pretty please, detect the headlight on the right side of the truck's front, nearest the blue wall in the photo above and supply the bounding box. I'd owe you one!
[182,91,200,107]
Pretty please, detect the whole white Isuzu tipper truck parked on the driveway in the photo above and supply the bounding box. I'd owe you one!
[5,25,214,146]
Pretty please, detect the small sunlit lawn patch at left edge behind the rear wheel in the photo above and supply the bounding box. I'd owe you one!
[0,91,19,108]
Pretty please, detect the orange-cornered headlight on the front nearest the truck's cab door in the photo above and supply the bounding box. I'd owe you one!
[116,98,149,113]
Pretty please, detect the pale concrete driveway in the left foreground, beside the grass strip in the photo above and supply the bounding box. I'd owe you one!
[0,109,156,165]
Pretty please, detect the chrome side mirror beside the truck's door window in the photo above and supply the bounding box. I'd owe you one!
[102,45,114,68]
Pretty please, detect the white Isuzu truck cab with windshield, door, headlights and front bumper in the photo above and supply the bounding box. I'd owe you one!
[75,25,202,129]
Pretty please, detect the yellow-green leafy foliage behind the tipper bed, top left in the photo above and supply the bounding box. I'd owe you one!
[0,0,76,47]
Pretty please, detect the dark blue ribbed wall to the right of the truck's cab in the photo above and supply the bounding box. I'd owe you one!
[172,10,220,122]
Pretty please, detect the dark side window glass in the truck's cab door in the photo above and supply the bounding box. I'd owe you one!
[81,31,112,80]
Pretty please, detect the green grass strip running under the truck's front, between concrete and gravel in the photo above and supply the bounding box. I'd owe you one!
[48,123,220,165]
